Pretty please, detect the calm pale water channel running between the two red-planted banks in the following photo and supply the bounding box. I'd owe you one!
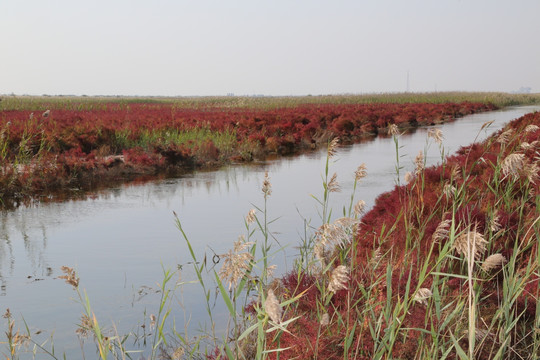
[0,106,540,358]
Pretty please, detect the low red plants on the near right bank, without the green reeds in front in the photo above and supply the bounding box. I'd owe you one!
[269,113,540,359]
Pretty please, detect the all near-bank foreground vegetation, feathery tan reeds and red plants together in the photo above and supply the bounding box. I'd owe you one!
[1,107,540,359]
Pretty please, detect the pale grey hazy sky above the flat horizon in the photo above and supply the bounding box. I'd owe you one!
[0,0,540,96]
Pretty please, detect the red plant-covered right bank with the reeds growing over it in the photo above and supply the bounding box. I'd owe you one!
[270,113,540,359]
